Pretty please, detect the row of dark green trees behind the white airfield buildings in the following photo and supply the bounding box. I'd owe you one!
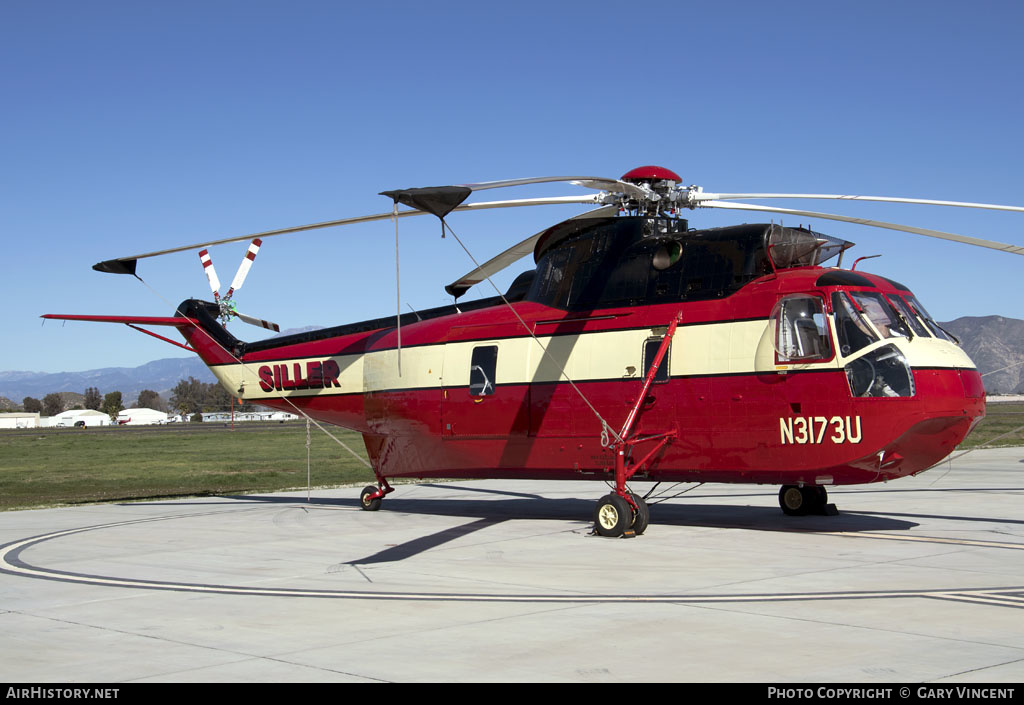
[22,377,262,419]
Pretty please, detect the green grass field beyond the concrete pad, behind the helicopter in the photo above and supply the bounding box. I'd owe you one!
[0,404,1024,510]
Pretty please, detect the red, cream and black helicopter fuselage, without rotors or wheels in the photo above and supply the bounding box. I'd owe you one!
[179,217,985,524]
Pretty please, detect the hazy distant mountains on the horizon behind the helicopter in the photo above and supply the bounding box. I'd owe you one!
[0,316,1024,408]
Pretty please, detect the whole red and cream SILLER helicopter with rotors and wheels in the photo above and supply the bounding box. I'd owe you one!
[43,166,1024,537]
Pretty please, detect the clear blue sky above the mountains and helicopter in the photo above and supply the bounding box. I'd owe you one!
[0,0,1024,372]
